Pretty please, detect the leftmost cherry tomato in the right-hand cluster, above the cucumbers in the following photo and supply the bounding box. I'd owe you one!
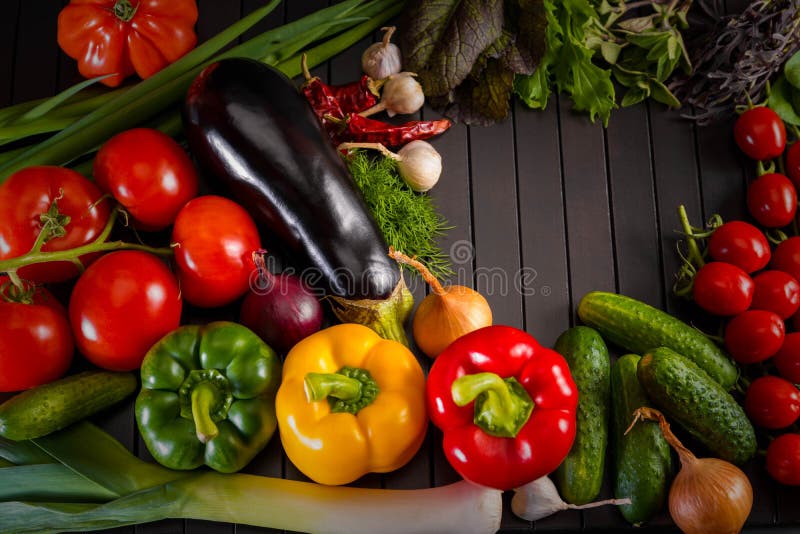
[692,261,754,315]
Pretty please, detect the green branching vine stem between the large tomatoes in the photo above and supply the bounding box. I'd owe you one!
[0,209,172,276]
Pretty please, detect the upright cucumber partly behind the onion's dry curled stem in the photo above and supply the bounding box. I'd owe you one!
[611,354,674,525]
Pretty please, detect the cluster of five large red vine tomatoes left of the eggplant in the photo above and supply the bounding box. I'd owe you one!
[0,128,268,392]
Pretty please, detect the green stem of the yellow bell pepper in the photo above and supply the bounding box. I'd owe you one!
[304,366,380,414]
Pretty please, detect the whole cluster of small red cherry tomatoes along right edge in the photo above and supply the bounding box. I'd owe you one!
[692,107,800,485]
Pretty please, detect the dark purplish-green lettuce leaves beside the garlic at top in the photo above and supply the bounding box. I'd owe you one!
[400,0,547,125]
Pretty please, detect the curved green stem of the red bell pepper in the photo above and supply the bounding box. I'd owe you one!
[450,373,533,438]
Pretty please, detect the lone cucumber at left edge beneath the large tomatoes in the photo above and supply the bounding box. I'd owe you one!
[0,371,136,441]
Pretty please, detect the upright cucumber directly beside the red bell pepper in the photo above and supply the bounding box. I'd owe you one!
[554,326,611,504]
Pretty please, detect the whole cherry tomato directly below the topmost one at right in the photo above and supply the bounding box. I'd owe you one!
[747,172,797,228]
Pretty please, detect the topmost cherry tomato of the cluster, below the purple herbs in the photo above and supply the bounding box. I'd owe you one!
[733,106,786,161]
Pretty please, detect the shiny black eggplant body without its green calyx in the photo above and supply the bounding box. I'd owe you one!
[183,58,400,300]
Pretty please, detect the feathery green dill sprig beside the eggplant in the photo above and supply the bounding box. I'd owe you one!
[347,150,453,279]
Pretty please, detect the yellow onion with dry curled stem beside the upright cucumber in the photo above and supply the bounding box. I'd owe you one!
[631,407,753,534]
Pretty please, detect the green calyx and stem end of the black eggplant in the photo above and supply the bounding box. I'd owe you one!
[330,274,414,346]
